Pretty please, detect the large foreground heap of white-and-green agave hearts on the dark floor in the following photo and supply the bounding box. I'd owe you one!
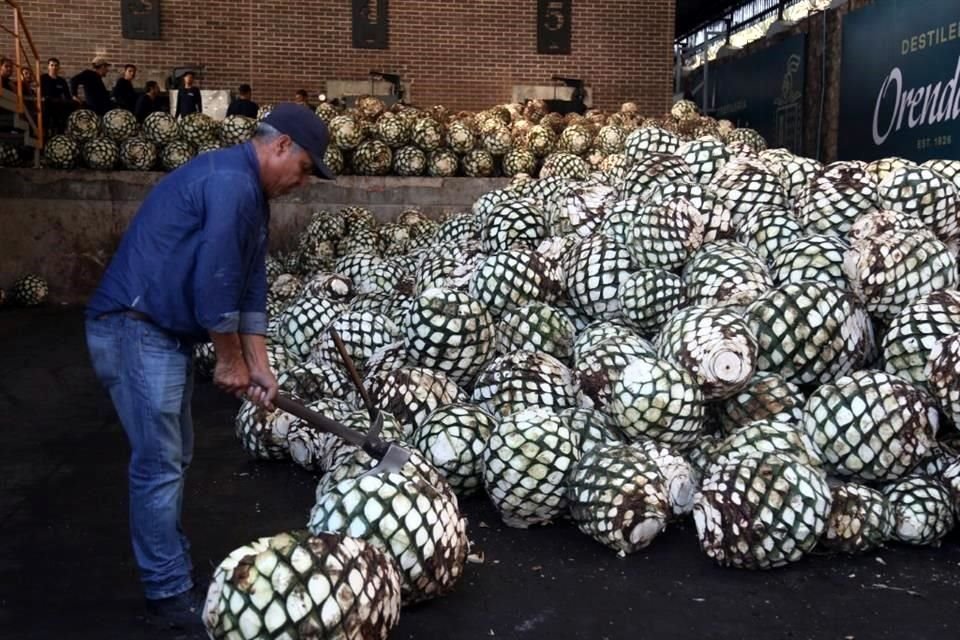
[197,100,960,638]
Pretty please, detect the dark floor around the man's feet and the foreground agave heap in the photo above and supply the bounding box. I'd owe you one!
[0,308,960,640]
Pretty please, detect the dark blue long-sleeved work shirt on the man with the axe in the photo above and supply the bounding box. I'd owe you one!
[87,142,270,341]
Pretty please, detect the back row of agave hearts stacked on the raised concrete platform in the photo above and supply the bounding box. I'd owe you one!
[39,96,758,179]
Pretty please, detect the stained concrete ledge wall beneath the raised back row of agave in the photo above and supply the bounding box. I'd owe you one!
[0,169,507,302]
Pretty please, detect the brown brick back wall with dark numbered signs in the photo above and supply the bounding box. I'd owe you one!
[0,0,675,114]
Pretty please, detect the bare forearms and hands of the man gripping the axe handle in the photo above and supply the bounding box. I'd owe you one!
[210,332,278,410]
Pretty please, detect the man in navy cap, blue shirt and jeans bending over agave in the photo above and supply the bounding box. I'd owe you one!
[87,103,333,628]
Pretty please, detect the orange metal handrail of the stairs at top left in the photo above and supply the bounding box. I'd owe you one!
[0,0,44,151]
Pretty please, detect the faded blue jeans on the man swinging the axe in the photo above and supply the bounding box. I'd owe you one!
[87,313,193,600]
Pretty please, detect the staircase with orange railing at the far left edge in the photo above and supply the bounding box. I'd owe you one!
[0,0,44,167]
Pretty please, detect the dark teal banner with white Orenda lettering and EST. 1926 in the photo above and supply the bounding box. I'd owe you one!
[837,0,960,162]
